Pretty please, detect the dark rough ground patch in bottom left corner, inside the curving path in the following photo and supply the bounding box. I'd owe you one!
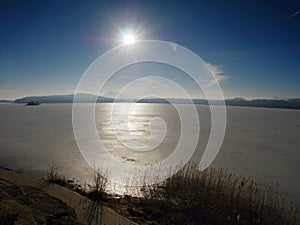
[0,179,82,225]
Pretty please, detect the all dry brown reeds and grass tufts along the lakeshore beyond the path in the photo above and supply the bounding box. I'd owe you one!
[47,163,299,225]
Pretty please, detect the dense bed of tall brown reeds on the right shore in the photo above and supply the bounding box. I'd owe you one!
[139,163,299,225]
